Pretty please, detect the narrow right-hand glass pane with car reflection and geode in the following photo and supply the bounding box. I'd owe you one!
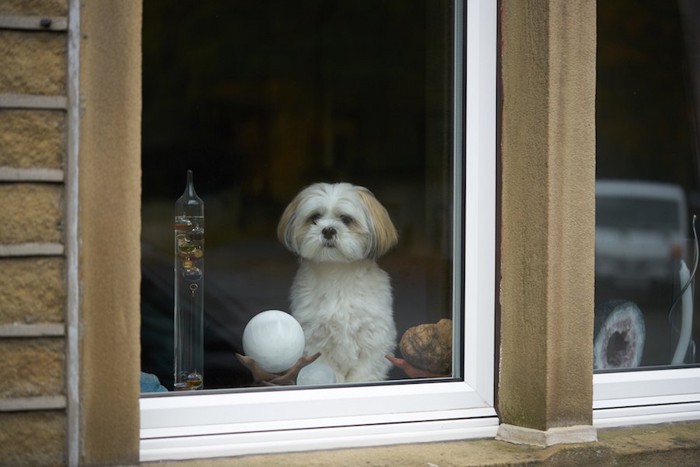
[594,0,700,371]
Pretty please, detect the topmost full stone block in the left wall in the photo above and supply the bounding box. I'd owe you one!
[0,31,67,95]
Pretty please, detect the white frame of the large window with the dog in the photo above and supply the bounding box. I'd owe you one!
[140,0,499,461]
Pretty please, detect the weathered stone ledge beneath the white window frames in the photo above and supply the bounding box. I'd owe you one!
[143,421,700,467]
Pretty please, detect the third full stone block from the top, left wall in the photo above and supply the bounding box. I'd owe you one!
[0,183,63,244]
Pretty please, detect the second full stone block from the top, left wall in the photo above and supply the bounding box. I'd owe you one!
[0,110,66,169]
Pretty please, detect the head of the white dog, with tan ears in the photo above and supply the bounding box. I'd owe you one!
[277,183,398,262]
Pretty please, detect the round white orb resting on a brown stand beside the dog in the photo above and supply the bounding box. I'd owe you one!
[243,310,306,373]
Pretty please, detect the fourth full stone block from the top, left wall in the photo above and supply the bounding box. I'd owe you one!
[0,258,66,324]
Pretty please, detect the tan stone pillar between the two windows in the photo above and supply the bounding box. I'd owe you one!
[498,0,596,440]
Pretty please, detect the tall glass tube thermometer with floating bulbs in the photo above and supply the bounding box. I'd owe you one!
[174,170,204,391]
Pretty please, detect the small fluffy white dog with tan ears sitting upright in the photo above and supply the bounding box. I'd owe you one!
[277,183,398,382]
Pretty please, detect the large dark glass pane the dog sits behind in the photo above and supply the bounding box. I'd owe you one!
[141,0,461,392]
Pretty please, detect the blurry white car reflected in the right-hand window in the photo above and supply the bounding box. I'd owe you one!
[595,180,688,287]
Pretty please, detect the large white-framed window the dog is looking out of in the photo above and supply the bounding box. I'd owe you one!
[141,0,498,460]
